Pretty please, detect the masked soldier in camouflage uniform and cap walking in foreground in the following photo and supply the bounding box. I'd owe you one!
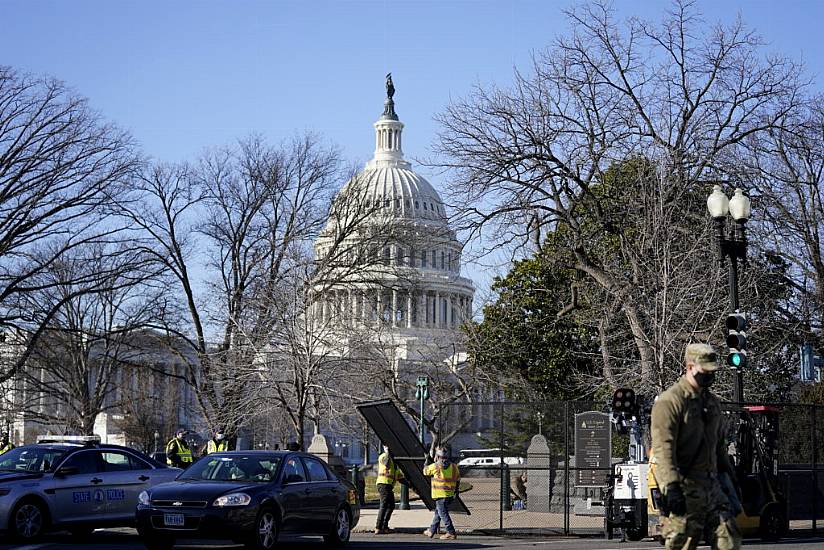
[652,344,741,550]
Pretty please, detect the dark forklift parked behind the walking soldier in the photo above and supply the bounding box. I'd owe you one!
[647,406,789,543]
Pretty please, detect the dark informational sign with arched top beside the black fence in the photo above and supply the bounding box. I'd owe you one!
[575,411,612,487]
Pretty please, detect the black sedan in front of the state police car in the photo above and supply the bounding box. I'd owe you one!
[137,451,360,550]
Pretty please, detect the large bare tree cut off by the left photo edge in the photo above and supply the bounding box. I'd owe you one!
[0,67,137,381]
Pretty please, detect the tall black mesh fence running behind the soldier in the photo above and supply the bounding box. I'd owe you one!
[434,401,824,535]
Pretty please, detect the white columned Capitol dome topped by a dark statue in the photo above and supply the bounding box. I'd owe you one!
[313,75,475,369]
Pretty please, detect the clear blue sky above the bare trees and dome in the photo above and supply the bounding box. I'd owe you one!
[0,0,824,294]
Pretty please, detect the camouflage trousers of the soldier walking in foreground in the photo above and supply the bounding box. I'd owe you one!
[661,478,741,550]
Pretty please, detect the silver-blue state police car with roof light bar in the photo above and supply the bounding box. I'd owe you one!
[0,443,180,542]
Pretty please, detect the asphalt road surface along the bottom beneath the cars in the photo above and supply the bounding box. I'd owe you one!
[0,529,824,550]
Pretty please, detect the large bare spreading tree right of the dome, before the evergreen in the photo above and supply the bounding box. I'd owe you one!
[432,2,804,389]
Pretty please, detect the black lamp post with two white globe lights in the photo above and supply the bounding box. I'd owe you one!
[707,185,752,403]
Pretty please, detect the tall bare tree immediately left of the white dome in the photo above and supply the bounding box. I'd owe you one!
[125,135,350,436]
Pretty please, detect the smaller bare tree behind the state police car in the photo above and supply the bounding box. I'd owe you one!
[17,242,165,435]
